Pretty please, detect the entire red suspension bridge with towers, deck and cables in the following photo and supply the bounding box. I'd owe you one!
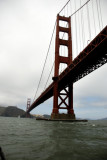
[26,0,107,119]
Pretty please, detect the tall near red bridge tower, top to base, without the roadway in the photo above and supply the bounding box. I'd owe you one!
[51,15,75,119]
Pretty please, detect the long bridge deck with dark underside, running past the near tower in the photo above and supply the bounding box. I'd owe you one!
[27,26,107,113]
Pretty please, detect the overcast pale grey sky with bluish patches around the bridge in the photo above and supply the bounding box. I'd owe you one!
[0,0,107,118]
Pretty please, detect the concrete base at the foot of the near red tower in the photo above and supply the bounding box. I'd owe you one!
[51,113,75,120]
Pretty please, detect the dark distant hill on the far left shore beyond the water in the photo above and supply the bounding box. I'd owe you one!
[0,106,31,118]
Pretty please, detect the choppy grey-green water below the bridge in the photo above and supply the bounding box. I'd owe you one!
[0,117,107,160]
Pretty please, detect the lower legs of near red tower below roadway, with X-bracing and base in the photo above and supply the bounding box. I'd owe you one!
[51,83,75,120]
